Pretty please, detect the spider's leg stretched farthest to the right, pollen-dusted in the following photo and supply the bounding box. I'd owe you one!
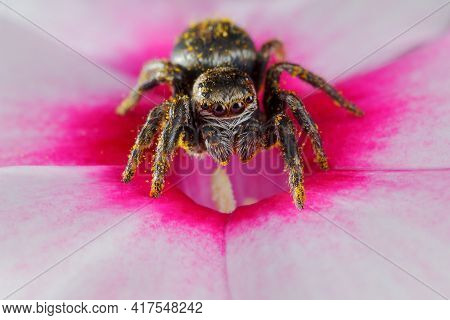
[268,62,364,116]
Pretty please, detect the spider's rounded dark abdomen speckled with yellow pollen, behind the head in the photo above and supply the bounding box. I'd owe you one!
[171,19,256,79]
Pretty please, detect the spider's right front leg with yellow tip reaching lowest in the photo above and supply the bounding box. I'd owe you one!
[264,112,305,209]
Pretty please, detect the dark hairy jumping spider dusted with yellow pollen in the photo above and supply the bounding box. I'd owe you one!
[117,20,362,208]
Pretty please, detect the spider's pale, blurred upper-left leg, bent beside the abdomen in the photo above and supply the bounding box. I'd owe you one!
[116,60,184,115]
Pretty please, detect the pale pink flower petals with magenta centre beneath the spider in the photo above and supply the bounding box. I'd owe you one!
[0,0,450,299]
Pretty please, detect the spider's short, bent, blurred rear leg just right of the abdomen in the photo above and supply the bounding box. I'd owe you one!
[255,39,285,91]
